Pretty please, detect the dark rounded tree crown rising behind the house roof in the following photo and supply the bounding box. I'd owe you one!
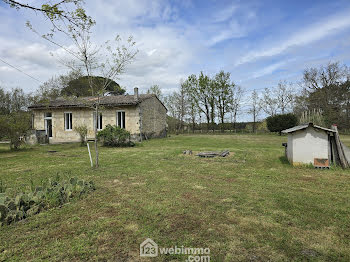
[61,76,125,97]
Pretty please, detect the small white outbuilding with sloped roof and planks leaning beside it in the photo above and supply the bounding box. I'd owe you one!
[282,123,348,168]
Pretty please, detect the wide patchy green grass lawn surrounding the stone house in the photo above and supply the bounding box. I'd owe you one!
[0,135,350,261]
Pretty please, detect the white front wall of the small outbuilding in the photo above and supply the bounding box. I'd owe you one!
[288,127,329,164]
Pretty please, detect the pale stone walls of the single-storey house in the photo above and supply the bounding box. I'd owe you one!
[32,96,166,143]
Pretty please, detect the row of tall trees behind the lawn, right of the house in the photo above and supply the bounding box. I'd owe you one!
[155,62,350,133]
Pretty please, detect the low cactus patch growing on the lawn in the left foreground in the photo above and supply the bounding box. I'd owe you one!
[0,178,95,226]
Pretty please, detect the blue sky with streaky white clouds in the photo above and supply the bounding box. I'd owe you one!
[0,0,350,120]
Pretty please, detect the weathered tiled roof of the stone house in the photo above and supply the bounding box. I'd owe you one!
[28,94,156,109]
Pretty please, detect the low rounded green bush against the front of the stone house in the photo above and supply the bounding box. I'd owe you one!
[97,125,134,147]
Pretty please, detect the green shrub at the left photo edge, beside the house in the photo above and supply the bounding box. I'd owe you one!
[0,112,31,149]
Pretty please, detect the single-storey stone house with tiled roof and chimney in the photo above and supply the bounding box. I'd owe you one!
[29,88,167,143]
